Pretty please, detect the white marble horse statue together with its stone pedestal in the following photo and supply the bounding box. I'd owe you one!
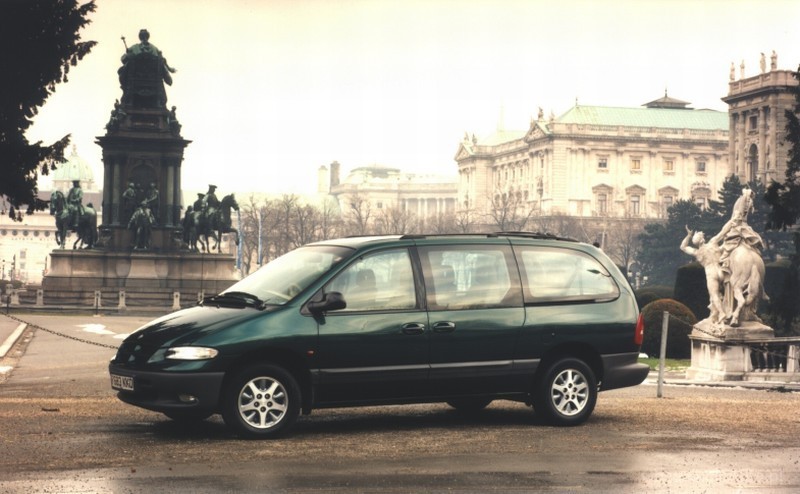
[680,186,775,380]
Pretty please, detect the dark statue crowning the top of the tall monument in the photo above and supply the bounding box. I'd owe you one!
[117,29,176,108]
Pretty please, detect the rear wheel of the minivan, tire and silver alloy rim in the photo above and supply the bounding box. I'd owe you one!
[533,358,597,426]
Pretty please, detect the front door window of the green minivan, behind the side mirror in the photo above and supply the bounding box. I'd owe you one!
[325,249,417,312]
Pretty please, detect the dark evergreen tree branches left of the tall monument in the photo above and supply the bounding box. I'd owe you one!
[0,0,96,219]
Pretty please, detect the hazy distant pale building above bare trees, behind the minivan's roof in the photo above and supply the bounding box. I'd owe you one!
[318,161,458,219]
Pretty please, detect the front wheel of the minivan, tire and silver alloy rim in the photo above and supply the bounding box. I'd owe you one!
[222,364,301,439]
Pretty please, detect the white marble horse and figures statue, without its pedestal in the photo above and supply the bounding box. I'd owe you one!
[681,187,767,328]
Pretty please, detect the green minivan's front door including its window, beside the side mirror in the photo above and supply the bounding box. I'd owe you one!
[315,247,429,405]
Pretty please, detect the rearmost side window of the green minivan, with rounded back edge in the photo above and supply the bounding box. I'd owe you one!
[514,246,619,303]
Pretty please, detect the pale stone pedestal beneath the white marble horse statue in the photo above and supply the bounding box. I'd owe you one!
[686,319,775,381]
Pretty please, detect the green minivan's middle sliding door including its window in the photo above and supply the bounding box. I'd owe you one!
[418,242,525,396]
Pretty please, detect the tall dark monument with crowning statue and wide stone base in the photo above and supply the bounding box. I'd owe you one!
[43,29,238,307]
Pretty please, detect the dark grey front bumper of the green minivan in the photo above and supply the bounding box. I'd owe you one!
[108,364,225,413]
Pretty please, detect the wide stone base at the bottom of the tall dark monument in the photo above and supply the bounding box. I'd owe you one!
[42,250,237,309]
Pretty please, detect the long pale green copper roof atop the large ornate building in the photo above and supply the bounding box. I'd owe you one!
[556,106,728,130]
